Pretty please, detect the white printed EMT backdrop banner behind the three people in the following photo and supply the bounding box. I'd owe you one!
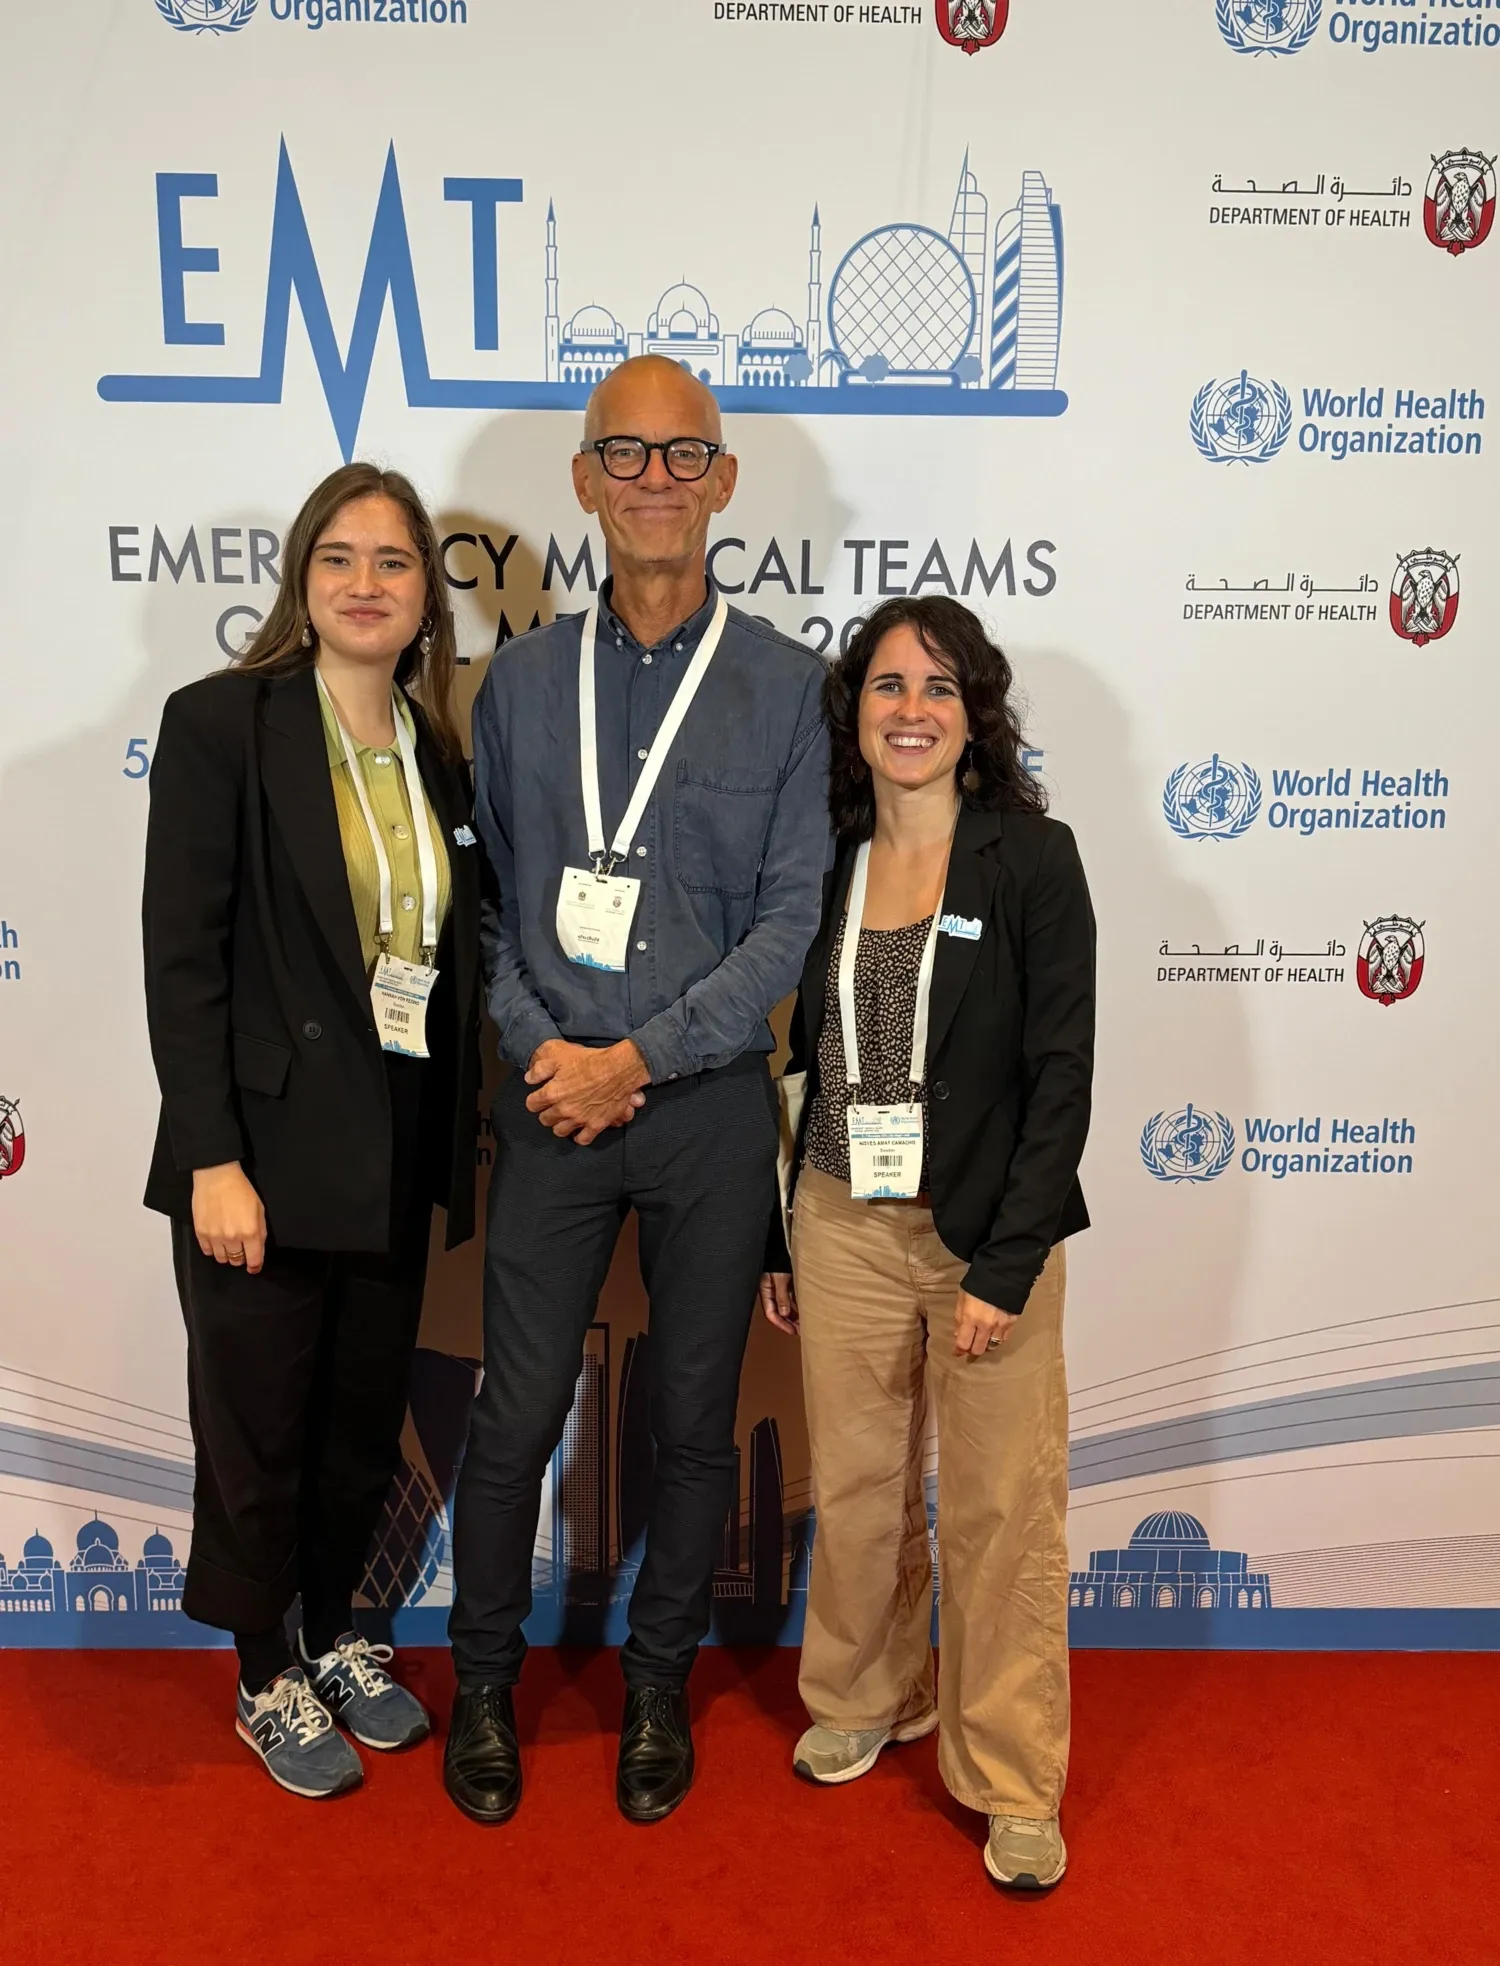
[0,0,1500,1646]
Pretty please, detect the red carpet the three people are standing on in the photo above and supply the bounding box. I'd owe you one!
[0,1649,1500,1966]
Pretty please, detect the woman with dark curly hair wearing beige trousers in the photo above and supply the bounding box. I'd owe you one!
[761,598,1093,1889]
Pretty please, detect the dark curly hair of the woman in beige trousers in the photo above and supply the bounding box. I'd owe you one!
[824,594,1048,839]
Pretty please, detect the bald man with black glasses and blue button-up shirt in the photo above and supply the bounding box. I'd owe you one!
[444,356,828,1822]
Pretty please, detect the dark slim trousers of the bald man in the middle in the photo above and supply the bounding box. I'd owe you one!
[448,1054,777,1687]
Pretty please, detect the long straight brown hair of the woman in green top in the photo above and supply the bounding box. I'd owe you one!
[234,464,464,759]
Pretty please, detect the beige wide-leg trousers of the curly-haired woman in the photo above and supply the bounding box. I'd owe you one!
[792,1168,1069,1819]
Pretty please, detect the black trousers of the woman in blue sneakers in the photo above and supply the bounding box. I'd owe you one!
[171,1054,433,1632]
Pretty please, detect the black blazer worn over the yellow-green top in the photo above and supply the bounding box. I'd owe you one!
[142,668,480,1250]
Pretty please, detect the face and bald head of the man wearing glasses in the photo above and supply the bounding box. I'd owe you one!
[572,356,737,572]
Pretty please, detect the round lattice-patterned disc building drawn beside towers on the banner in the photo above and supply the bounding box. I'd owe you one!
[828,224,979,381]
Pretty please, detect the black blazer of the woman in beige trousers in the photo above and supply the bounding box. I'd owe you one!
[767,806,1093,1311]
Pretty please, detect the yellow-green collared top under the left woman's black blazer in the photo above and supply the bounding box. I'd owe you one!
[318,690,452,969]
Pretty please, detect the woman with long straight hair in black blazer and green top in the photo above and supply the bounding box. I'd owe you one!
[144,464,480,1797]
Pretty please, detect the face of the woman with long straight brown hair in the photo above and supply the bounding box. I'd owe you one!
[307,495,427,663]
